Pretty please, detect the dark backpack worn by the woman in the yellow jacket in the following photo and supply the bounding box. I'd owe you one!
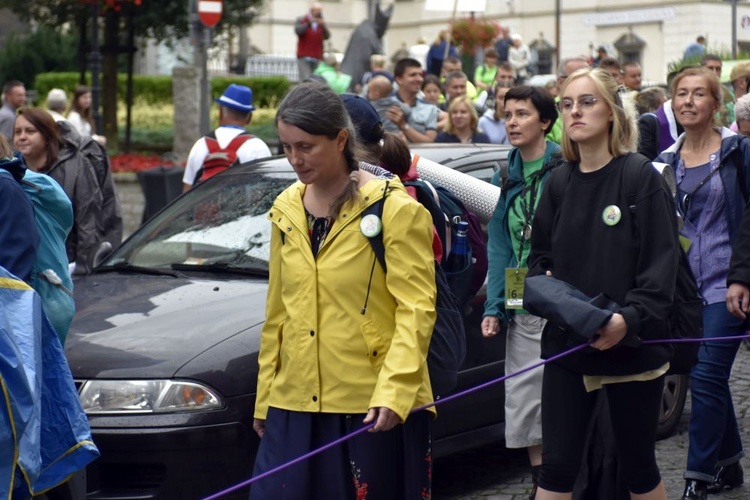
[362,186,466,399]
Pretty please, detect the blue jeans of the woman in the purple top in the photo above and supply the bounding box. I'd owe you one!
[685,302,745,481]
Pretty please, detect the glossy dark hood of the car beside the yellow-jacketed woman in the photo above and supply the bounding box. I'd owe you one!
[65,272,268,379]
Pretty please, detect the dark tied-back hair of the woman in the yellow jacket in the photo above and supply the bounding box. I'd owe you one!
[275,82,359,218]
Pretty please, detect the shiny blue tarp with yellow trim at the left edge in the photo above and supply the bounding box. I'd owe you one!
[0,267,99,498]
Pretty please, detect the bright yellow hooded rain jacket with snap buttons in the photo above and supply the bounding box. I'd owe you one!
[255,178,436,420]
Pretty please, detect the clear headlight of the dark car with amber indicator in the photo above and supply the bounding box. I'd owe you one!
[78,380,224,414]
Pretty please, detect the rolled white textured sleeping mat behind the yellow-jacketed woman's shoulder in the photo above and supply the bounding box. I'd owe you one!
[417,156,500,222]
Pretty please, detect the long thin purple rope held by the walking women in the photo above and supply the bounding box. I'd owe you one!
[203,334,750,500]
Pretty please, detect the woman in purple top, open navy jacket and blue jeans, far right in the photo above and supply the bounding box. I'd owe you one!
[657,68,750,500]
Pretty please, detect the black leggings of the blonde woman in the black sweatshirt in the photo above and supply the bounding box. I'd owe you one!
[539,363,664,494]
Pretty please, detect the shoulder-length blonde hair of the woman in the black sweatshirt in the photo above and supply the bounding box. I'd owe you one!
[560,68,638,162]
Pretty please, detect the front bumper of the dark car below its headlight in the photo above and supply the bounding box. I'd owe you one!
[87,396,259,500]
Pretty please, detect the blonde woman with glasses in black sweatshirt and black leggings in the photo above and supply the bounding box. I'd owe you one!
[529,69,679,500]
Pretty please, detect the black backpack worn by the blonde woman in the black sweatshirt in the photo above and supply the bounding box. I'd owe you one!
[547,153,703,374]
